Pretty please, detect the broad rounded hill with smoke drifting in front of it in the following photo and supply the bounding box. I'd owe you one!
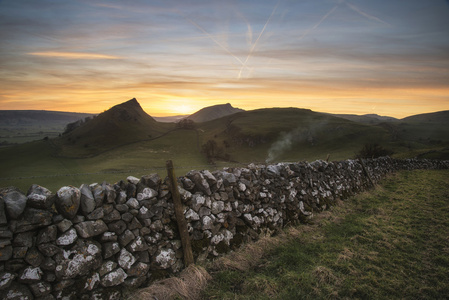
[194,108,389,162]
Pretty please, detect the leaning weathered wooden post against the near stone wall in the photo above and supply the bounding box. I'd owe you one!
[166,160,194,267]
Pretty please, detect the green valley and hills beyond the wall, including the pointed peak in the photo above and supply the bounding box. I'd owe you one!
[0,99,449,191]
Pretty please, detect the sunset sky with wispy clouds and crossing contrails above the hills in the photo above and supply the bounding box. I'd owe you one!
[0,0,449,118]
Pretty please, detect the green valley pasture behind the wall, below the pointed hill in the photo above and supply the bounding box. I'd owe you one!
[0,130,206,192]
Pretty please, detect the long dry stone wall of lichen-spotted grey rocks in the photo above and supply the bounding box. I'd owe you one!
[0,157,449,299]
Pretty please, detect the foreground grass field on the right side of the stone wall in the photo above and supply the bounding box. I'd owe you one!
[203,170,449,299]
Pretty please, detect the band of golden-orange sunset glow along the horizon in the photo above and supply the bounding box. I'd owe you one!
[0,84,449,118]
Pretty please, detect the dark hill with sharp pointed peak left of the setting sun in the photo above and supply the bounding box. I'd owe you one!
[54,99,173,157]
